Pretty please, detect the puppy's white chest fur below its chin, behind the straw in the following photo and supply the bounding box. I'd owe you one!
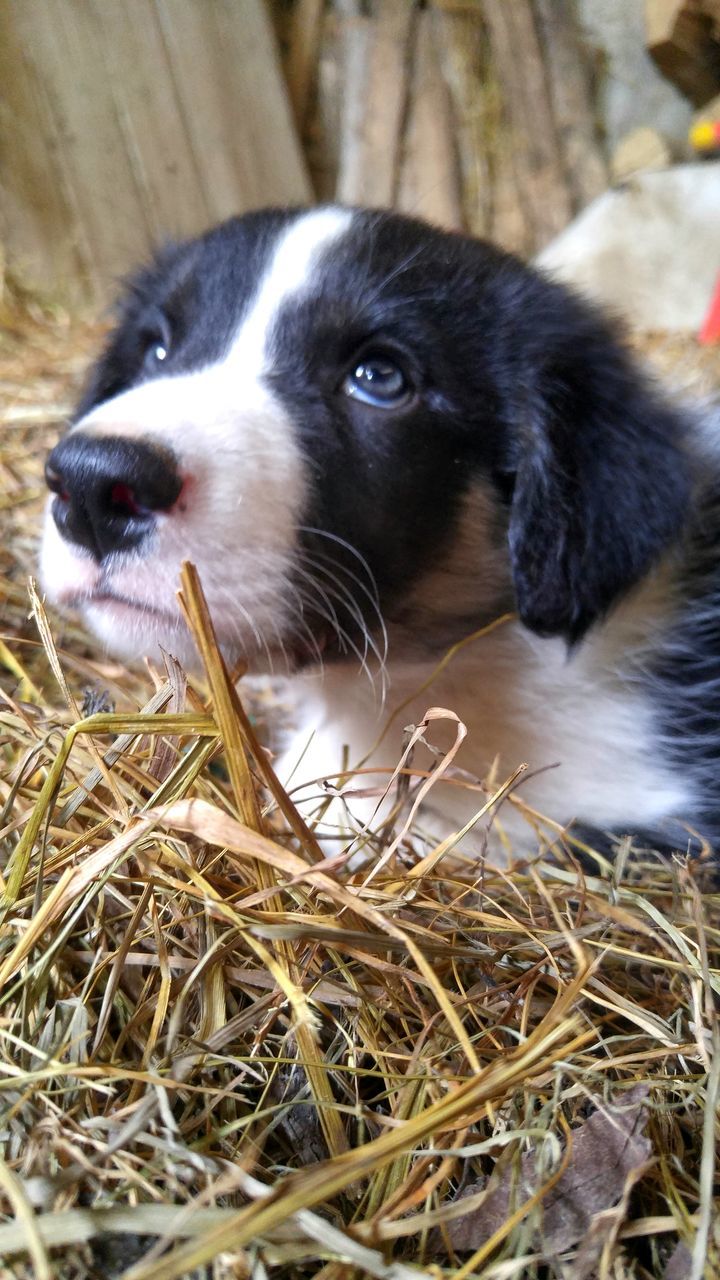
[281,626,691,845]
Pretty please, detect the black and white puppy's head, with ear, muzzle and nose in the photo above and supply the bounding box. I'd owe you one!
[41,207,688,663]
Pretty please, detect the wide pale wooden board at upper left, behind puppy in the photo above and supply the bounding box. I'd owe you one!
[0,0,311,298]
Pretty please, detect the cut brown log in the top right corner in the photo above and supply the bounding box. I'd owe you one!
[644,0,720,106]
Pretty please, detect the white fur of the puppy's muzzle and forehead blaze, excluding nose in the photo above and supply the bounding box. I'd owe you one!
[41,209,352,669]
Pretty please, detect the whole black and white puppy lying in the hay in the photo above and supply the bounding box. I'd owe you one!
[41,207,720,849]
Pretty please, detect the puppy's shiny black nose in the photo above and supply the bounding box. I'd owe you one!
[45,431,182,561]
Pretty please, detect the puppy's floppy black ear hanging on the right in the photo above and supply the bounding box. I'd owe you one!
[510,305,691,643]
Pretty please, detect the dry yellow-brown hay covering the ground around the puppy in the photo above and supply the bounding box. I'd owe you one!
[0,294,720,1280]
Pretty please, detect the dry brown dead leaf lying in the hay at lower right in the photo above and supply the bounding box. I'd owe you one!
[448,1085,652,1256]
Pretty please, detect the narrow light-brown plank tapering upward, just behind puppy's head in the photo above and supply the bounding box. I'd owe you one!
[396,10,462,230]
